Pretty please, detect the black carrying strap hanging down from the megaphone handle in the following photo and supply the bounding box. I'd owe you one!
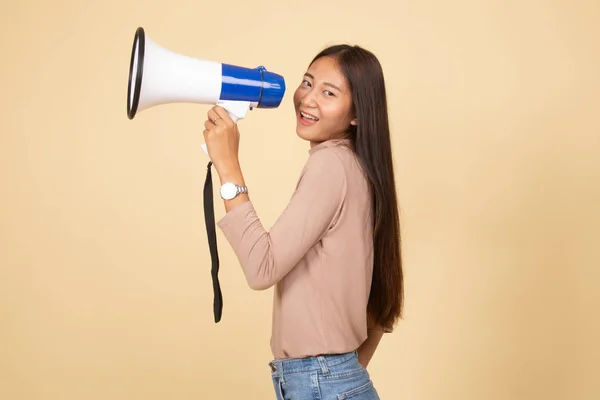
[204,161,223,323]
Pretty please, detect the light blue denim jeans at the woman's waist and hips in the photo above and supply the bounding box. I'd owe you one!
[269,351,379,400]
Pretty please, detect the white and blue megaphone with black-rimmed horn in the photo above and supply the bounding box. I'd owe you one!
[127,27,285,154]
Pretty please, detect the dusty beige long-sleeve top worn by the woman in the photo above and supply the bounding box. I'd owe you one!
[218,139,373,359]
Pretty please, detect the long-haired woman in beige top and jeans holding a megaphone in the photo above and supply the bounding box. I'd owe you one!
[204,45,403,400]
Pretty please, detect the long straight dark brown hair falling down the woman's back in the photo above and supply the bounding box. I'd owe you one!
[311,44,404,329]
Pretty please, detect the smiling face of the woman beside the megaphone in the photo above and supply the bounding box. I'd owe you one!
[294,57,356,147]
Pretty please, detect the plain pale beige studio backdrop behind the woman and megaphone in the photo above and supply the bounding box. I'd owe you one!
[0,0,600,400]
